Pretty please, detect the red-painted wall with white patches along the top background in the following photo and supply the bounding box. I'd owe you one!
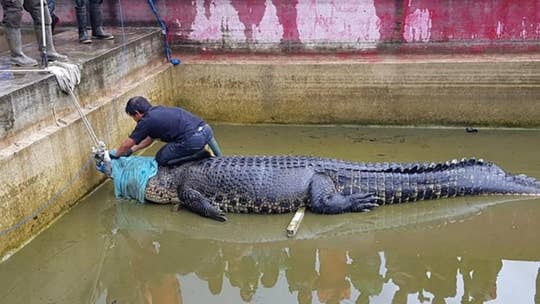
[5,0,540,52]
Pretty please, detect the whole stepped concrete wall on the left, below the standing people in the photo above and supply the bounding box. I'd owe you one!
[0,28,167,256]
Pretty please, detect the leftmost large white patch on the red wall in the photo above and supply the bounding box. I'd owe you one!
[190,0,246,42]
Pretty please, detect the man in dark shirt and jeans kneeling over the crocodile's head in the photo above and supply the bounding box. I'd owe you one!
[111,96,221,166]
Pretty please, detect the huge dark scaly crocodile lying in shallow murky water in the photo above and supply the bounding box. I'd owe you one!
[136,156,540,221]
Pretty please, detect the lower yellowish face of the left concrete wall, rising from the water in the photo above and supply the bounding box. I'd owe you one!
[0,67,173,257]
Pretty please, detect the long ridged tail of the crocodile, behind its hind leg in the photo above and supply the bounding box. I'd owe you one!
[326,159,540,204]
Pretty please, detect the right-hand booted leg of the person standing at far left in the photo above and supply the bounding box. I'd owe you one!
[23,0,67,61]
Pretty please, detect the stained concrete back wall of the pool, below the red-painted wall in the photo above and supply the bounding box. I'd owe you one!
[171,54,540,127]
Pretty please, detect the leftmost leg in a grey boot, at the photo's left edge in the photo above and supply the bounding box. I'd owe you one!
[0,0,37,67]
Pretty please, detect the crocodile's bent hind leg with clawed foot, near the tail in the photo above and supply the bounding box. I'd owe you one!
[309,174,379,214]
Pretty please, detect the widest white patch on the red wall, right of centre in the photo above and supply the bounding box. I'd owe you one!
[297,0,381,47]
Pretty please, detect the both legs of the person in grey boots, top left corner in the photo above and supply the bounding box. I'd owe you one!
[0,0,67,67]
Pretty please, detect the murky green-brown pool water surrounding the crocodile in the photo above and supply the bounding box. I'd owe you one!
[0,125,540,304]
